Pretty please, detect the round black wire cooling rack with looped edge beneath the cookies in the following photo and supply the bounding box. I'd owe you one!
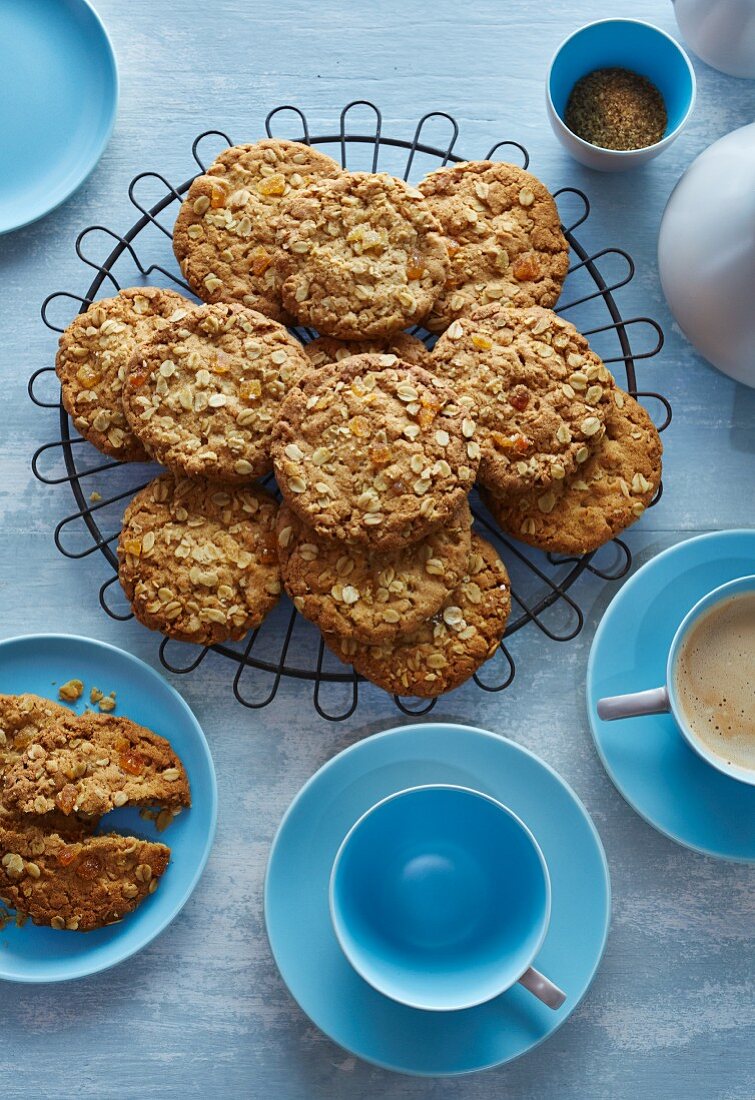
[29,100,671,721]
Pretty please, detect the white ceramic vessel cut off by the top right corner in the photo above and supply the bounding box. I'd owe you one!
[672,0,755,78]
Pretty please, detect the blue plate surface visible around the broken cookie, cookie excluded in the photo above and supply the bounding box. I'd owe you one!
[0,634,218,982]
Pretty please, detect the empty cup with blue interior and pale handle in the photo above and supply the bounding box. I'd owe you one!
[330,785,565,1011]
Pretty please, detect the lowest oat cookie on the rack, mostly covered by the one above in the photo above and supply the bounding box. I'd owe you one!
[324,535,511,699]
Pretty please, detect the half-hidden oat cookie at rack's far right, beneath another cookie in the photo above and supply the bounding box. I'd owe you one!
[483,389,663,554]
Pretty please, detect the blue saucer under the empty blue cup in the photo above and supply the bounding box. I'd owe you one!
[265,722,610,1077]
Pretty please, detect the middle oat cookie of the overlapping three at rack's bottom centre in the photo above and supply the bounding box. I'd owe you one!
[277,501,472,644]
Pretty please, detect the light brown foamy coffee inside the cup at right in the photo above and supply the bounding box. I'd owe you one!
[675,592,755,770]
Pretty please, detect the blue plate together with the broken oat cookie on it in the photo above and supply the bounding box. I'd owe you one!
[0,635,217,982]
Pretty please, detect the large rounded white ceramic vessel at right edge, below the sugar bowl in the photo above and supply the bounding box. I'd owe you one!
[658,122,755,387]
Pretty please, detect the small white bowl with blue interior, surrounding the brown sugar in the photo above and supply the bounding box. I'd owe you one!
[546,19,696,172]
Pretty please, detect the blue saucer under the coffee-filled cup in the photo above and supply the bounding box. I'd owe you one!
[587,530,755,861]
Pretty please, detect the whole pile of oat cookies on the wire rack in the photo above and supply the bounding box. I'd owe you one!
[57,140,660,696]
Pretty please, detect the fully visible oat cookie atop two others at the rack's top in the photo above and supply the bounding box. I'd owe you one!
[275,172,448,340]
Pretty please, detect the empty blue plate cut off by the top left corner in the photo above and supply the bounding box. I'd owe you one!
[0,0,118,233]
